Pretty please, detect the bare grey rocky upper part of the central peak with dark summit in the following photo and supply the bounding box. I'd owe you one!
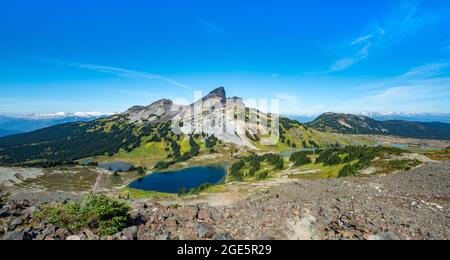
[124,87,270,148]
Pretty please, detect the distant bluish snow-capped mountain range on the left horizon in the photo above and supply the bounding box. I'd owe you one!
[0,112,115,133]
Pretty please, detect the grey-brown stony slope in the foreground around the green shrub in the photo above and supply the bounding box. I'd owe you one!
[0,163,450,240]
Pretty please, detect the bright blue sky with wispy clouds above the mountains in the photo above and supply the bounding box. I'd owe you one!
[0,0,450,115]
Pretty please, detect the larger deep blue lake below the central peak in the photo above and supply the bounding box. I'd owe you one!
[129,166,226,193]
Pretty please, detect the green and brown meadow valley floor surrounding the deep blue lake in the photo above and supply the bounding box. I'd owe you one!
[0,136,450,204]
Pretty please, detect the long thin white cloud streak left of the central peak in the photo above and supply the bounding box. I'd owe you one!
[41,59,191,89]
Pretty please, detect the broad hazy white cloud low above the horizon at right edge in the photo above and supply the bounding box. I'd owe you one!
[336,61,450,113]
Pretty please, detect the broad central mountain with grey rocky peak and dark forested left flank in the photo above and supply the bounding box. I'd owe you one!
[0,87,348,165]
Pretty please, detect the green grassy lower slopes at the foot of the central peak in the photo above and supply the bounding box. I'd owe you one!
[90,116,376,174]
